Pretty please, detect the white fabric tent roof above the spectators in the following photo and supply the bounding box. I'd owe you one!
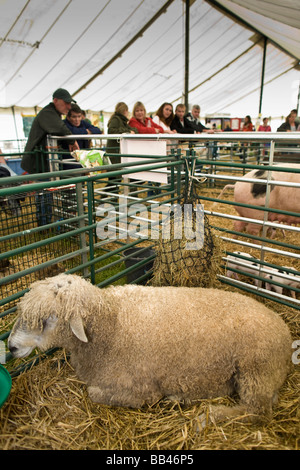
[0,0,300,113]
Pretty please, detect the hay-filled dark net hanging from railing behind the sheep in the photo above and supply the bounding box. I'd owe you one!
[150,169,222,287]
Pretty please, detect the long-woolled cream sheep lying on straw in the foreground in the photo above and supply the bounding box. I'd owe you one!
[8,274,292,421]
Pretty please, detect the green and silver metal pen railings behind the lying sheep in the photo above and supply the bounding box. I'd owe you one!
[0,132,300,374]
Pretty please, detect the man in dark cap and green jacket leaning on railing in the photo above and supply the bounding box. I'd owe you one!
[21,88,79,174]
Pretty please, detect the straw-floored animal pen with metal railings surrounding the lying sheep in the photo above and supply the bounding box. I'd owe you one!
[0,133,300,450]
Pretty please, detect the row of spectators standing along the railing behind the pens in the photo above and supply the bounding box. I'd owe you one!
[17,88,300,174]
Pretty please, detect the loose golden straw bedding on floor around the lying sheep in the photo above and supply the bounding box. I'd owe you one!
[0,179,300,451]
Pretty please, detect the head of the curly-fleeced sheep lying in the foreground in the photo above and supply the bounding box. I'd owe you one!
[8,274,93,357]
